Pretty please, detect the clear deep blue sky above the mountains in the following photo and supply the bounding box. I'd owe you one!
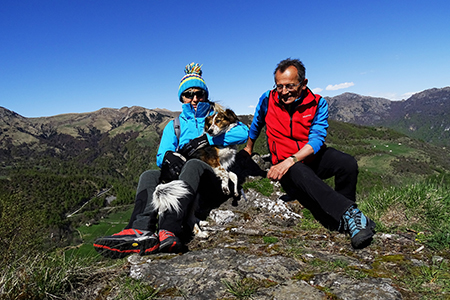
[0,0,450,117]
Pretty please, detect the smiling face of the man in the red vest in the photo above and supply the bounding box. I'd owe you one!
[275,66,308,104]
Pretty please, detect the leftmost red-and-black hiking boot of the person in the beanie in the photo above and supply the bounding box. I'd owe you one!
[94,229,159,258]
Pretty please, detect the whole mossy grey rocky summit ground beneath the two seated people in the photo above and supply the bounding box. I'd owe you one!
[59,166,442,300]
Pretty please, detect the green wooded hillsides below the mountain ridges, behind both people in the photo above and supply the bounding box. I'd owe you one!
[0,121,450,262]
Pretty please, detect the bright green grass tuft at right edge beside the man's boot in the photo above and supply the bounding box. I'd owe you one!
[359,175,450,250]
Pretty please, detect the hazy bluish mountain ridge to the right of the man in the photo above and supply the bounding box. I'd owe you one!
[326,87,450,146]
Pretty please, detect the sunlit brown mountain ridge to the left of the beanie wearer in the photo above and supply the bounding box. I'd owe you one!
[0,106,179,165]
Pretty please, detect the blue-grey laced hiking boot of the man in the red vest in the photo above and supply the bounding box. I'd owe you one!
[341,206,375,249]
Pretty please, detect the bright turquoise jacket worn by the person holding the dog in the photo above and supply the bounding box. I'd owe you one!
[156,102,249,167]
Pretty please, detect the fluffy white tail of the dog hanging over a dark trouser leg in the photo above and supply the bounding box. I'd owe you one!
[152,180,191,214]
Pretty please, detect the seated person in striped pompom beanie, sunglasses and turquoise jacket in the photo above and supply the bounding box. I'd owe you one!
[94,63,248,258]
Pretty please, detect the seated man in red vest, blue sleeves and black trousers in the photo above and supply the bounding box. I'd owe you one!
[244,58,375,248]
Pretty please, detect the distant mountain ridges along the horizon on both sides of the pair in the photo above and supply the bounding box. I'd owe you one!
[0,87,450,163]
